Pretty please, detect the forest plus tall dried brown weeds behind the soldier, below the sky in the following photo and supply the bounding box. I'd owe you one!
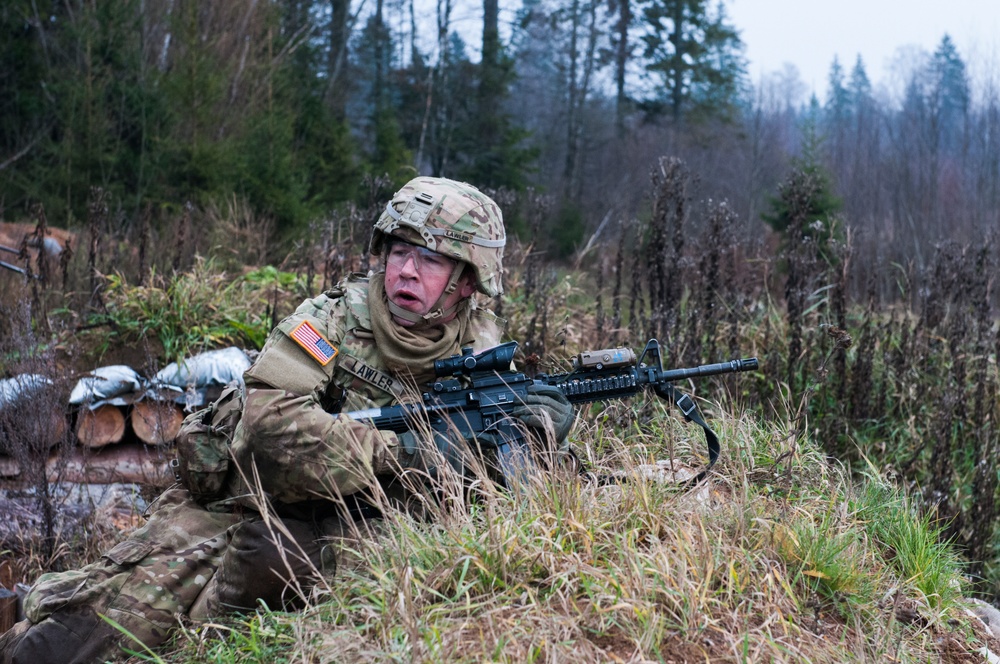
[0,0,1000,594]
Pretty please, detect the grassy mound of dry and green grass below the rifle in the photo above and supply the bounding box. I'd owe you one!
[163,407,976,662]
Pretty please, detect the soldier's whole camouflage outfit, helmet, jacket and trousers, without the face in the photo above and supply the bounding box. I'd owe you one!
[0,178,504,664]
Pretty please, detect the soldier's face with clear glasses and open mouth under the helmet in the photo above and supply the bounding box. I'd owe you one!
[385,240,476,327]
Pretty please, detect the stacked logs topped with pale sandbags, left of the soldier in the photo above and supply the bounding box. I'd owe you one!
[0,348,250,486]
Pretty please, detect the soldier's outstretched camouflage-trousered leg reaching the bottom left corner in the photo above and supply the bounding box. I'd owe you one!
[0,489,240,664]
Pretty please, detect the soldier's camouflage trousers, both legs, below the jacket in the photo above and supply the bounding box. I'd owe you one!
[0,489,340,664]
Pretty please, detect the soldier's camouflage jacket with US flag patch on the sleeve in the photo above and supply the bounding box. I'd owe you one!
[229,275,502,503]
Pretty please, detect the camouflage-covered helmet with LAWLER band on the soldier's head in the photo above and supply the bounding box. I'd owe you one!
[369,177,507,297]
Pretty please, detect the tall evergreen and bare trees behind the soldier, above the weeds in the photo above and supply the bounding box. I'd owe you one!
[0,0,1000,252]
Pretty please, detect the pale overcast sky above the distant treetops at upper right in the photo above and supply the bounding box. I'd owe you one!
[726,0,1000,99]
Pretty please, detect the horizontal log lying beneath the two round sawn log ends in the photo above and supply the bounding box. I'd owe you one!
[0,443,175,488]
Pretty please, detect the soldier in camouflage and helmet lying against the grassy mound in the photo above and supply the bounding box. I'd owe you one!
[0,177,573,664]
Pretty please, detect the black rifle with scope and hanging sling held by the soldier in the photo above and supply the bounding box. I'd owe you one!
[346,339,758,487]
